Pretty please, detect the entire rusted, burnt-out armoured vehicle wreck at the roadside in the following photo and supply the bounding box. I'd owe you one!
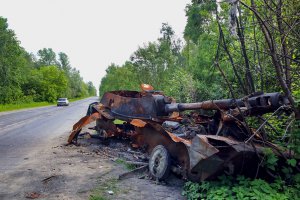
[68,84,289,181]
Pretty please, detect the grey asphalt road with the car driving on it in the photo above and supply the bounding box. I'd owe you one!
[0,97,98,170]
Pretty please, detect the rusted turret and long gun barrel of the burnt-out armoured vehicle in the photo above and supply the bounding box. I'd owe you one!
[100,91,288,120]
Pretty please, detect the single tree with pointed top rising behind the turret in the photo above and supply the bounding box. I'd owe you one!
[130,23,184,89]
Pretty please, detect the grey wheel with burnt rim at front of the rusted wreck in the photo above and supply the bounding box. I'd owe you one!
[149,145,171,180]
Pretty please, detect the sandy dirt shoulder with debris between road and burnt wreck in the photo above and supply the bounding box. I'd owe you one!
[0,127,184,200]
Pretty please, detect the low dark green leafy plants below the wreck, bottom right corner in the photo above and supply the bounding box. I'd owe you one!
[183,174,300,200]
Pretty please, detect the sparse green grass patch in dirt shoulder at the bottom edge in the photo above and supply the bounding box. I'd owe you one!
[89,178,120,200]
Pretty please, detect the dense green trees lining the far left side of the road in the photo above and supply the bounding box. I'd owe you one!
[0,17,96,105]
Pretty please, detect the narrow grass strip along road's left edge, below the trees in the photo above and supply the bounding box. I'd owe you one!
[0,97,96,112]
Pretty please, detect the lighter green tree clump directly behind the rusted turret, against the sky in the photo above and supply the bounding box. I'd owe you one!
[99,23,199,102]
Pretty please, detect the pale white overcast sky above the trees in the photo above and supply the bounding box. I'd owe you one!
[0,0,190,89]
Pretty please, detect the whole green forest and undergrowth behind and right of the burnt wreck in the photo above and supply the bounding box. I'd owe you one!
[99,0,300,199]
